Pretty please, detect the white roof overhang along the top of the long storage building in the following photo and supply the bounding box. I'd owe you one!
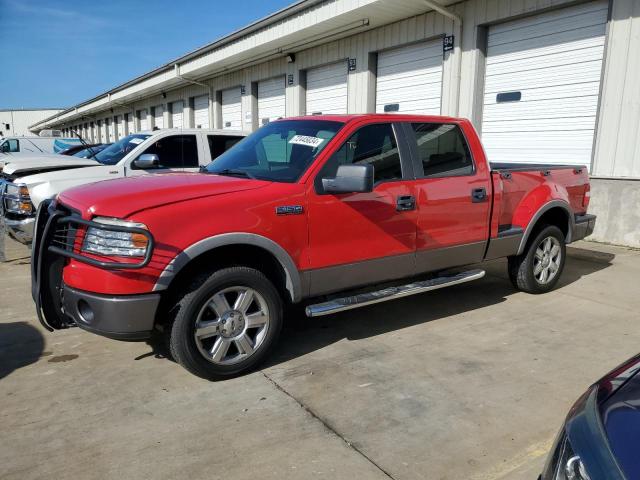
[29,0,452,131]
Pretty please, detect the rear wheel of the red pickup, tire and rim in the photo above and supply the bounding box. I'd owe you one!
[509,225,566,293]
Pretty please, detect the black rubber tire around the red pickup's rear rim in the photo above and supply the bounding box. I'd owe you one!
[508,225,567,294]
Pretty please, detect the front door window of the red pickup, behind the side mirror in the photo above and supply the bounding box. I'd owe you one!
[316,123,402,186]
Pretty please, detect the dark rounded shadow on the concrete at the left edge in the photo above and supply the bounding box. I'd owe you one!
[0,322,44,380]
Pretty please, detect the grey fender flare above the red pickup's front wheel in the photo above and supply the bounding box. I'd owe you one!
[153,232,302,302]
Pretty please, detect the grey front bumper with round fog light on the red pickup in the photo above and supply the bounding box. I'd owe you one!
[62,285,160,340]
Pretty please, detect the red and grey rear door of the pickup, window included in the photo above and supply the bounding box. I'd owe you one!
[404,123,491,272]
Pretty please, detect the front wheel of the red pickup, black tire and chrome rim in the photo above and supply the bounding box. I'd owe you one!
[170,267,282,380]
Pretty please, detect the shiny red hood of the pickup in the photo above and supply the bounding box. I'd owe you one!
[58,173,270,218]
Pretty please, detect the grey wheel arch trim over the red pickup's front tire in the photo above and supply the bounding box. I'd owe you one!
[153,233,303,303]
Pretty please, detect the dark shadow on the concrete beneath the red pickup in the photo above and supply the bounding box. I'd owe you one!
[144,247,615,376]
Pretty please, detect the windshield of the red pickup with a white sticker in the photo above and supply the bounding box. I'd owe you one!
[206,120,344,182]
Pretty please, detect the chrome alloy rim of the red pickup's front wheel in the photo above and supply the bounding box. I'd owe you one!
[194,286,269,365]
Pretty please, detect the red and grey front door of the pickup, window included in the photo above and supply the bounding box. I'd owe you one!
[307,123,417,295]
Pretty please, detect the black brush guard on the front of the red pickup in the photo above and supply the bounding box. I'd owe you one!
[31,200,154,332]
